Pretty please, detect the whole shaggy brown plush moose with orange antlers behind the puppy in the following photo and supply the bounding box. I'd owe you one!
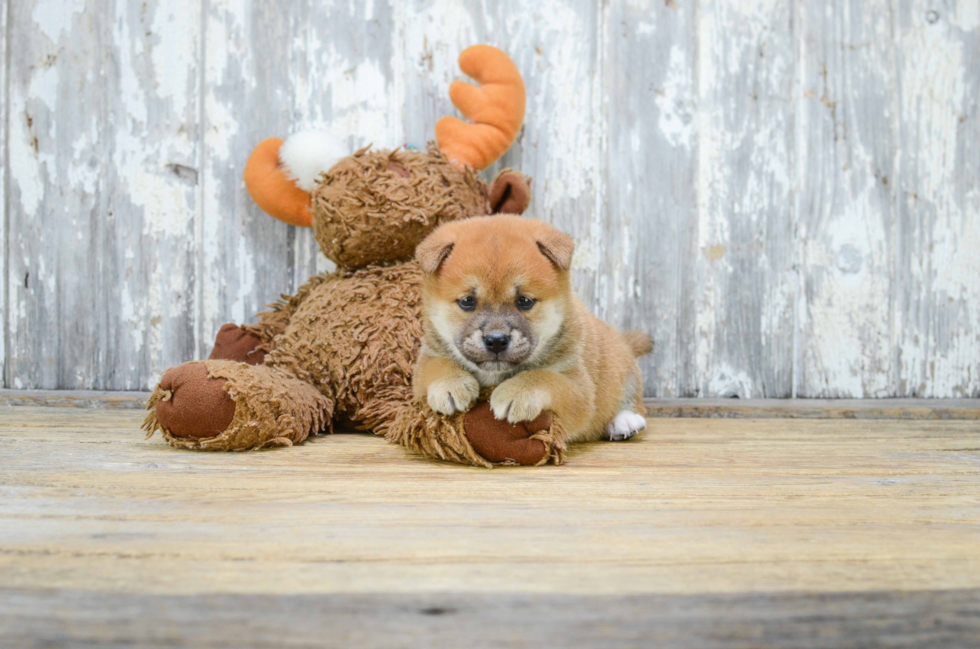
[144,45,565,466]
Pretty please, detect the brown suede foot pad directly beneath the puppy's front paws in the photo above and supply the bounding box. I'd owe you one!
[463,401,552,465]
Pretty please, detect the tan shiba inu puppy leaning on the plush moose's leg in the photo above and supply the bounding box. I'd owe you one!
[413,215,652,442]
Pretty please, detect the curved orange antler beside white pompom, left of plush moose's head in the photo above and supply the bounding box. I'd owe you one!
[244,137,313,228]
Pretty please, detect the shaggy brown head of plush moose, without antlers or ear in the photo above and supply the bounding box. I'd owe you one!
[310,144,490,268]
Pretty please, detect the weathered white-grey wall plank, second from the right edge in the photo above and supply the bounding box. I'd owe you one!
[796,0,900,398]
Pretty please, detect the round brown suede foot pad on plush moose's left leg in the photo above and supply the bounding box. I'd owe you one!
[156,363,235,439]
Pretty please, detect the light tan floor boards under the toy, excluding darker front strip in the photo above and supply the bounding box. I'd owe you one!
[0,407,980,595]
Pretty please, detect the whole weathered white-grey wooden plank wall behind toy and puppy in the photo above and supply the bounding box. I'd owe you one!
[0,0,980,398]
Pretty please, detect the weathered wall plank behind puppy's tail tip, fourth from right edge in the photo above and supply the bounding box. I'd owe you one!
[596,3,701,397]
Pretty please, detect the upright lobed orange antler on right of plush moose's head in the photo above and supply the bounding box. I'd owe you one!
[436,45,525,169]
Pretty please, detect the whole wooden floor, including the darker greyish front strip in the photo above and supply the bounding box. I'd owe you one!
[0,406,980,647]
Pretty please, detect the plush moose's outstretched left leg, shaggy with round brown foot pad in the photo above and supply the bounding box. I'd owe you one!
[143,360,333,451]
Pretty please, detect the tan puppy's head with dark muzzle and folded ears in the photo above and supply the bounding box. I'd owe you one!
[416,215,575,381]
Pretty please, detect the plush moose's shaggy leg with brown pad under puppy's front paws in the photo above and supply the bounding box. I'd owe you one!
[386,393,566,468]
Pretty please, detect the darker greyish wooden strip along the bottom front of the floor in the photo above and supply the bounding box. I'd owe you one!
[0,589,980,649]
